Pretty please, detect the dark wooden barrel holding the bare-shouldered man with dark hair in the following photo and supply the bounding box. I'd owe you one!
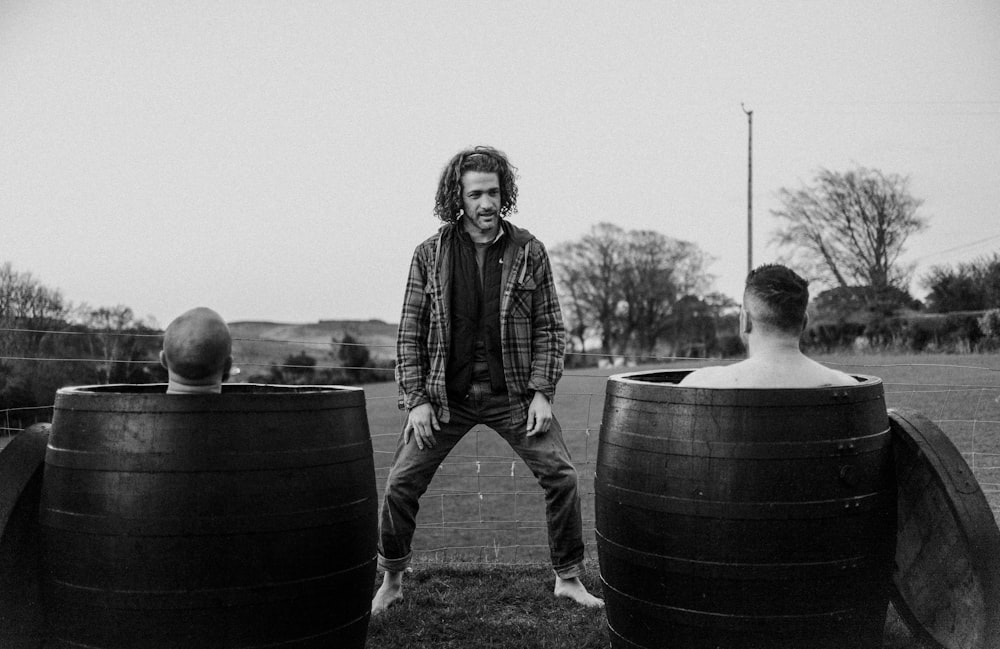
[594,370,896,649]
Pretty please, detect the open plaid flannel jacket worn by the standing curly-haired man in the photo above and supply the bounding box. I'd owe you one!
[396,220,566,424]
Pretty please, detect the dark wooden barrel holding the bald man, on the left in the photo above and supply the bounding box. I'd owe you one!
[40,384,378,649]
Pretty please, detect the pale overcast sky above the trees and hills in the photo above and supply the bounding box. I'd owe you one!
[0,0,1000,326]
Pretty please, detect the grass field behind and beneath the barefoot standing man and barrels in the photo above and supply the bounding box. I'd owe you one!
[365,355,1000,649]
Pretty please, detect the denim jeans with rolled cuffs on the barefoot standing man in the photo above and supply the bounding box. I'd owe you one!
[378,383,583,579]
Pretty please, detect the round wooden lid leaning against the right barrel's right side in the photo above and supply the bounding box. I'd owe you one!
[889,409,1000,649]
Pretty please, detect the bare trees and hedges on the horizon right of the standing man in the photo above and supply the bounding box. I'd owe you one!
[552,167,1000,357]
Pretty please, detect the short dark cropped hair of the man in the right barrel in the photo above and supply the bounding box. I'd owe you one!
[744,264,809,334]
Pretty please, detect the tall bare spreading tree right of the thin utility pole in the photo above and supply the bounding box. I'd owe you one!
[772,167,926,306]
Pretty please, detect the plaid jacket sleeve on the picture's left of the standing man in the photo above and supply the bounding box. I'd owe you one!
[396,242,434,410]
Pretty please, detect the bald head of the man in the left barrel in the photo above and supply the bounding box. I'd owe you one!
[160,307,233,394]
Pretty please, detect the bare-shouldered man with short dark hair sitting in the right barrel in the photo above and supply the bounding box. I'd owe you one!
[680,264,857,388]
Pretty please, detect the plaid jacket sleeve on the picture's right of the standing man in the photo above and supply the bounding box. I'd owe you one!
[517,239,566,401]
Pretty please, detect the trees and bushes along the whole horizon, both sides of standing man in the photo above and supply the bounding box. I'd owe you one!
[0,167,1000,409]
